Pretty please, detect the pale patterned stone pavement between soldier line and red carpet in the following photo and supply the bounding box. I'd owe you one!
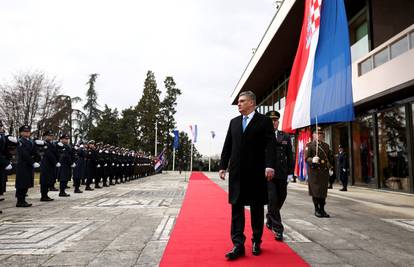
[0,173,188,266]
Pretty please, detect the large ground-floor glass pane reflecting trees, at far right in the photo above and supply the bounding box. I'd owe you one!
[377,106,410,192]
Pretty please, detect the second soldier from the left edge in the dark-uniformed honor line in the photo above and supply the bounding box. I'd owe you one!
[15,125,40,208]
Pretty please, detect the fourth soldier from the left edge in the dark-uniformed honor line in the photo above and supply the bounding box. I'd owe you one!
[58,134,76,197]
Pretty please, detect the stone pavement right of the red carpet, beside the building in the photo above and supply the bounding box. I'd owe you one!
[206,173,414,267]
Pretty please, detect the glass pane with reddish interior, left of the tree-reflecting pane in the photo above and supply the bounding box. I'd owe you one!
[352,115,377,187]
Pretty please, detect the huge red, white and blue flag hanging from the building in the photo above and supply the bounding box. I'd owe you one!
[282,0,355,132]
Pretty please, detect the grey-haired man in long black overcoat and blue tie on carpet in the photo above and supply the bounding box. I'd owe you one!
[219,91,276,260]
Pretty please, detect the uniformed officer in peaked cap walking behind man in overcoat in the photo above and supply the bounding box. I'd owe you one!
[266,111,293,241]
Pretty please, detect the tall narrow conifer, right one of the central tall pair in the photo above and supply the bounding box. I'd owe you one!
[158,77,181,162]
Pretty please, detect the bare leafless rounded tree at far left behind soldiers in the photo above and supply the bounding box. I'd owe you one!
[0,71,60,135]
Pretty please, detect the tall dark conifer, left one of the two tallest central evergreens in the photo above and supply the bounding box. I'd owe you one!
[136,70,161,156]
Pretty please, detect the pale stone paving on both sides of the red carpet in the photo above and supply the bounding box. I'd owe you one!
[0,172,414,267]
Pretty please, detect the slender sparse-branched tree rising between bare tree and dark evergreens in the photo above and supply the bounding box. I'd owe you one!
[83,73,101,136]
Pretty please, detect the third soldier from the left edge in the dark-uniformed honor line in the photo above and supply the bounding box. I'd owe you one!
[40,131,63,201]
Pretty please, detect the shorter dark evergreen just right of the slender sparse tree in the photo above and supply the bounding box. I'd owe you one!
[89,105,121,146]
